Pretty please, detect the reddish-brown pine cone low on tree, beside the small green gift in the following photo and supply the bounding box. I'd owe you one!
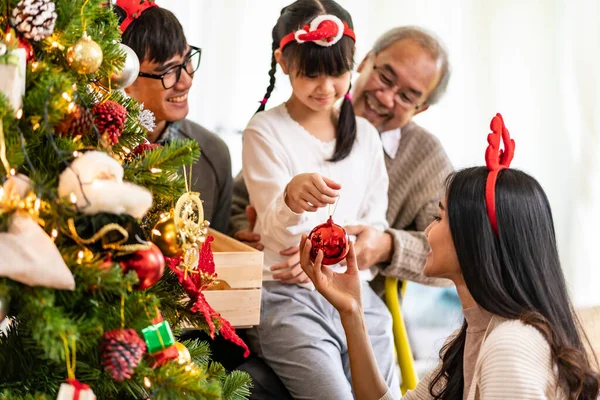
[101,329,146,382]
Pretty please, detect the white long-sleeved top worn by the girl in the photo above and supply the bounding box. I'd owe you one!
[242,104,388,286]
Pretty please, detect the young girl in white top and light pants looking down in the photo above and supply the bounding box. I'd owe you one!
[243,0,399,400]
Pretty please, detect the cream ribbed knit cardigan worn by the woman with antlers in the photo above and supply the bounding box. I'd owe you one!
[380,317,567,400]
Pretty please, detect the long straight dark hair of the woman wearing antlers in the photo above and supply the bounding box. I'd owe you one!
[429,167,600,400]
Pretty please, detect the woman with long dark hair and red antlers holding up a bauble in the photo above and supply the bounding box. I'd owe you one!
[300,114,600,400]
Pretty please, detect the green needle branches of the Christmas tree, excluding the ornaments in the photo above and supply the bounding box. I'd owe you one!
[0,0,250,400]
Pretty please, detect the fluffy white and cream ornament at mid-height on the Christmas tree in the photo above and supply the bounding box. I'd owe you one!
[58,151,152,219]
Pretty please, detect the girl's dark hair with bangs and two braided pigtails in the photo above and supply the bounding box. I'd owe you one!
[256,0,356,161]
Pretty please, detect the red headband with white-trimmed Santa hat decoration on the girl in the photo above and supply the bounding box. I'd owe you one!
[279,15,356,50]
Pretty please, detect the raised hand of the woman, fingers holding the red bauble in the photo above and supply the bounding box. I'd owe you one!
[300,235,361,314]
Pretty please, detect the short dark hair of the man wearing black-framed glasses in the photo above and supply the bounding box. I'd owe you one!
[113,6,187,64]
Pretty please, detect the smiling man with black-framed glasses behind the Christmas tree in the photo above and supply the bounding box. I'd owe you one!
[115,0,232,232]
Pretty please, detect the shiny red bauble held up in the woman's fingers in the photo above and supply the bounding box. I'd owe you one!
[308,217,349,265]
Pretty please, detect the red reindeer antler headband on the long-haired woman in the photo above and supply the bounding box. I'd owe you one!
[485,114,515,235]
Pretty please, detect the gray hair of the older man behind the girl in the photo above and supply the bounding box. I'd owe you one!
[371,26,450,104]
